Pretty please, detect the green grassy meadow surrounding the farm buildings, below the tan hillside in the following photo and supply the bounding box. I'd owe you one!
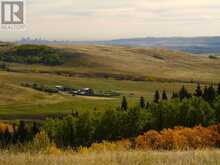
[0,71,199,120]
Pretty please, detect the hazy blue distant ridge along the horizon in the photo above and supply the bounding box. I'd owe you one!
[18,37,220,54]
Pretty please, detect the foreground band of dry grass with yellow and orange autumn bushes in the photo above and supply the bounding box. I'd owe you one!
[0,125,220,165]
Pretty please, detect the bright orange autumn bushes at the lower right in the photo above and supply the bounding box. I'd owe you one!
[135,124,220,150]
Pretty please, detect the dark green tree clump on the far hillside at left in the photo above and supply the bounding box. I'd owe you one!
[0,45,64,65]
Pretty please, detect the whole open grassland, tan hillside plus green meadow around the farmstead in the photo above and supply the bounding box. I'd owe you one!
[0,46,220,120]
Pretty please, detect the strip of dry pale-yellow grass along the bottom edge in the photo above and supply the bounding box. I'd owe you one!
[0,150,220,165]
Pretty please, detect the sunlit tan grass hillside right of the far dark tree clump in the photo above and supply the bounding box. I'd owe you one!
[50,46,220,81]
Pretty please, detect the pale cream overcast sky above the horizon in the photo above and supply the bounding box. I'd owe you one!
[0,0,220,41]
